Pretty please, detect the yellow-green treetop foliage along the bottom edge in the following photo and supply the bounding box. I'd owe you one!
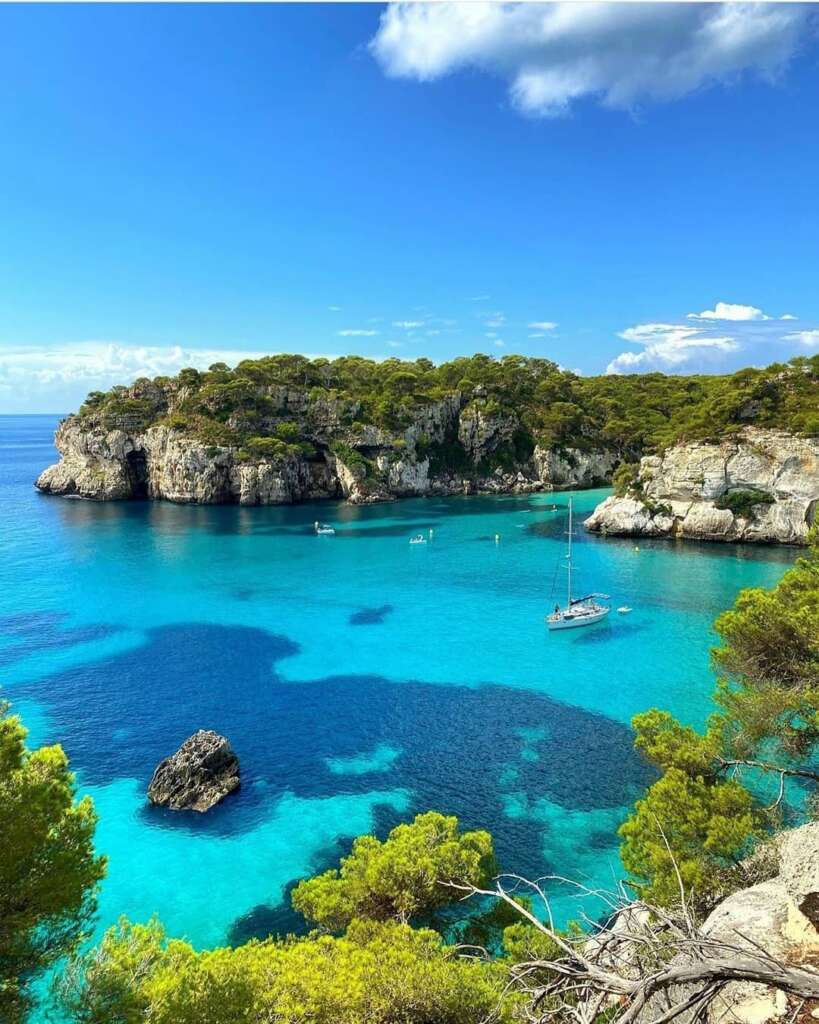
[64,921,519,1024]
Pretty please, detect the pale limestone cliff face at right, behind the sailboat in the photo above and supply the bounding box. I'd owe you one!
[586,428,819,544]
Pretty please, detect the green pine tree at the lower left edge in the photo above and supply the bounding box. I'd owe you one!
[0,706,105,1024]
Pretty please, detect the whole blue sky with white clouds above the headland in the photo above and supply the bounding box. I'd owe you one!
[0,4,819,412]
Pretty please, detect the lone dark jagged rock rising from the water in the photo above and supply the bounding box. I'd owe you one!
[147,729,240,811]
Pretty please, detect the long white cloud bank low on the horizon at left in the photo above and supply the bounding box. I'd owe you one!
[0,341,290,413]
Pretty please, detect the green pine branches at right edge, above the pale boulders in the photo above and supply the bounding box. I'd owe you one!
[620,530,819,907]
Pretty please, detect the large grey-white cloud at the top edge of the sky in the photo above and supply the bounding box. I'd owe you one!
[370,0,811,117]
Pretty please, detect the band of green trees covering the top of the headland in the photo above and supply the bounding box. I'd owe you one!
[80,354,819,461]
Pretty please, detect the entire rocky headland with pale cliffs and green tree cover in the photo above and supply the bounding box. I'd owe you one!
[36,354,819,524]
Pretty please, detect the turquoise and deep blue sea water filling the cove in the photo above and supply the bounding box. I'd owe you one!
[0,417,793,946]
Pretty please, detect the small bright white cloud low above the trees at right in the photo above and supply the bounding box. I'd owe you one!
[606,324,739,374]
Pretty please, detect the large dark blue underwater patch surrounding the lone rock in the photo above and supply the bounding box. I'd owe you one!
[17,624,653,874]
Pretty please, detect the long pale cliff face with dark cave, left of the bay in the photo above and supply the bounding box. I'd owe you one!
[37,388,617,505]
